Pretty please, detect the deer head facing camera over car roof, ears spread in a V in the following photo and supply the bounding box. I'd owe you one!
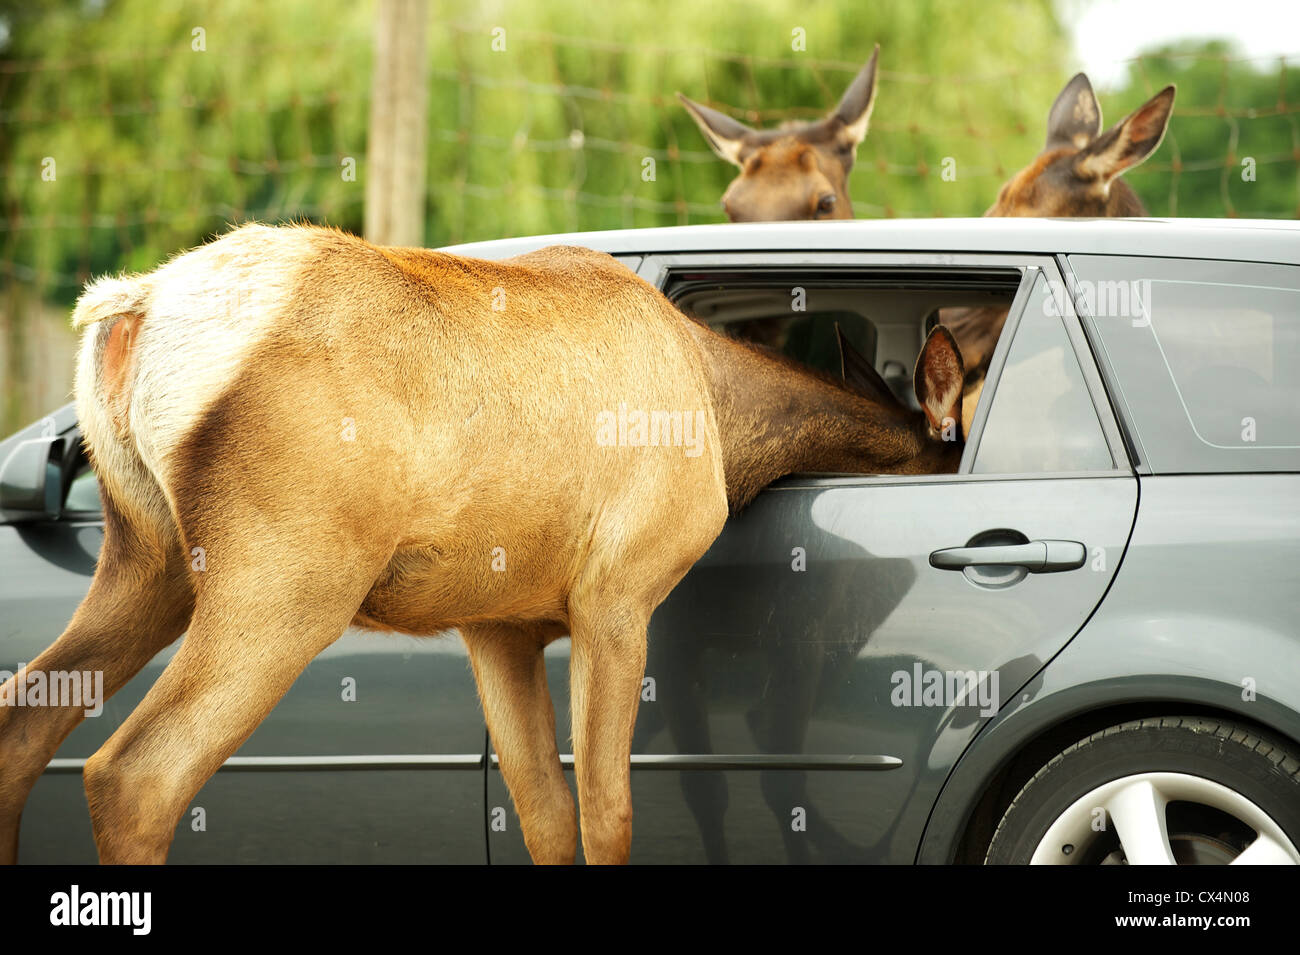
[677,43,880,222]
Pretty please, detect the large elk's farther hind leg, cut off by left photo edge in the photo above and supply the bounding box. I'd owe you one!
[0,492,194,864]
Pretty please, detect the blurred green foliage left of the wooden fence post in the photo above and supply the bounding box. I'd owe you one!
[0,0,371,299]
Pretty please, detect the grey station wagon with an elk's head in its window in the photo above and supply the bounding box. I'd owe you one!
[0,220,1300,864]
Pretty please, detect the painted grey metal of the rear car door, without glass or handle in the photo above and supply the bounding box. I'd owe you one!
[489,242,1136,863]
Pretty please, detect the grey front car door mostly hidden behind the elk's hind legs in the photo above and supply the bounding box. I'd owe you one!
[0,433,486,864]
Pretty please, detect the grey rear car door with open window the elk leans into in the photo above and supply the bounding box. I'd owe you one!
[488,253,1138,863]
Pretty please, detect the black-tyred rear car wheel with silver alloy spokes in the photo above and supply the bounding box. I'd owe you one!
[984,716,1300,865]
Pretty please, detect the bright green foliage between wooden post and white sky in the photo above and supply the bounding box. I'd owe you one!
[430,0,1066,239]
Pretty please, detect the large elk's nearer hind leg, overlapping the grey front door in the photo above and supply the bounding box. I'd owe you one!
[77,534,386,863]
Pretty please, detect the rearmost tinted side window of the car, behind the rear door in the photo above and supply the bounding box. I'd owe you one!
[1070,256,1300,474]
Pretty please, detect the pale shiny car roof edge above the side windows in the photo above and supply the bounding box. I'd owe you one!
[442,218,1300,264]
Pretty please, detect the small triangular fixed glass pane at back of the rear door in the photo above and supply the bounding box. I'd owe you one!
[972,275,1114,474]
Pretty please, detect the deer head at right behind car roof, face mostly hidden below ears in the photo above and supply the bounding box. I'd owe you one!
[984,73,1174,217]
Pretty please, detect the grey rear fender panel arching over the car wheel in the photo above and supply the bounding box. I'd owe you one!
[918,474,1300,863]
